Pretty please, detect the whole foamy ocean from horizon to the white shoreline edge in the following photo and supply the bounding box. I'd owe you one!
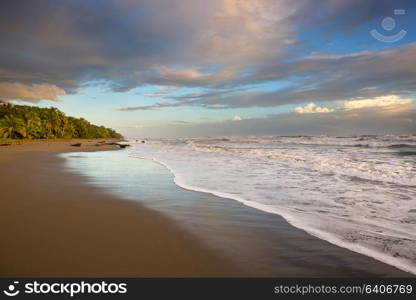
[127,135,416,274]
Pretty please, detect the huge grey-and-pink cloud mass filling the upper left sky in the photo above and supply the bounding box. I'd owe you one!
[0,0,293,92]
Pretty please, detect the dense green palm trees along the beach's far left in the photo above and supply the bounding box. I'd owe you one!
[0,102,122,139]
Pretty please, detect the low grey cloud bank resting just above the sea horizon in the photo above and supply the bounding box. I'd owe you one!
[123,107,416,137]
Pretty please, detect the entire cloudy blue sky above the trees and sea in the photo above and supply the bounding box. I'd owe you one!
[0,0,416,137]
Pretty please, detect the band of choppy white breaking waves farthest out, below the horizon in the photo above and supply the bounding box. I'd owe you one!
[188,142,416,185]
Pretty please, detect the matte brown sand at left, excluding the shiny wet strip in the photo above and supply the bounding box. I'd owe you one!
[0,141,243,277]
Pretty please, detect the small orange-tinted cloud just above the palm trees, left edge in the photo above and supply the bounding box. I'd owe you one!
[0,82,66,102]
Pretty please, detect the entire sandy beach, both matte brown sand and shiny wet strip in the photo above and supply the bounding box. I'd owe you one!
[0,141,411,277]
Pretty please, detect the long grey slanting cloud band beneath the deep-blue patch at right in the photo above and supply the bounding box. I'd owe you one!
[189,43,416,108]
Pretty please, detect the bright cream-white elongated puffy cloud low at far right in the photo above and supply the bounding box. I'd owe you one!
[342,95,412,110]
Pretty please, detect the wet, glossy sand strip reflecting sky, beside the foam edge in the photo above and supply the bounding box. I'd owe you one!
[65,150,412,277]
